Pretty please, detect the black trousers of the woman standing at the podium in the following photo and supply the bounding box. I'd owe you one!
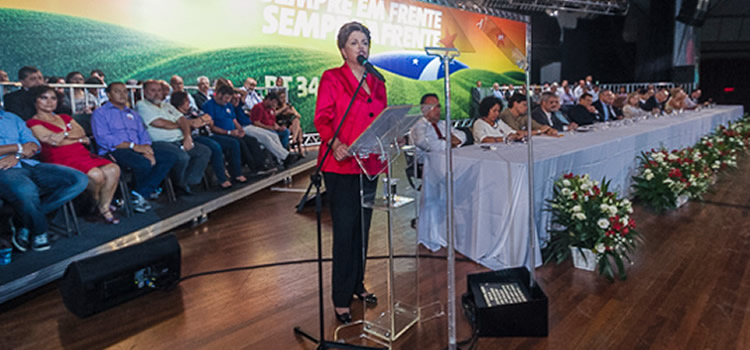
[323,173,378,307]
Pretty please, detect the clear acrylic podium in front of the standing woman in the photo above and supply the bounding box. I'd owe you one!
[334,105,442,348]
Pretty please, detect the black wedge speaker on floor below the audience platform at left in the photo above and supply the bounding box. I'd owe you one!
[59,234,180,318]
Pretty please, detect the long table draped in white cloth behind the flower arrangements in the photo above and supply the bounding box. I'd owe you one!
[417,106,743,269]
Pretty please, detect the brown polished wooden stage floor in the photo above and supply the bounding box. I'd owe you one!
[0,158,750,350]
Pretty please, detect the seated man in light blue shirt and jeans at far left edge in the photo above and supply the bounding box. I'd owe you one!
[0,110,89,252]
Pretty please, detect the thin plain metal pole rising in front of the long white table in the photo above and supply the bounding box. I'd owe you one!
[523,21,536,287]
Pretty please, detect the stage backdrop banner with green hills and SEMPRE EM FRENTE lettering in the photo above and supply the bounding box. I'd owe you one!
[0,0,526,132]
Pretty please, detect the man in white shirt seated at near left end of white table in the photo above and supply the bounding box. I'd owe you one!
[411,93,466,164]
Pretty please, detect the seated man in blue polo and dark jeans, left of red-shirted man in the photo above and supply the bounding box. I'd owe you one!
[201,85,274,174]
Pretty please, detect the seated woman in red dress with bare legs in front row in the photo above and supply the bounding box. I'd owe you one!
[26,85,120,224]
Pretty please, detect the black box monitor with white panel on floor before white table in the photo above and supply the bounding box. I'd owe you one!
[467,267,548,337]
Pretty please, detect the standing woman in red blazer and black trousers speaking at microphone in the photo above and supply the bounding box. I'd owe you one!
[315,22,388,323]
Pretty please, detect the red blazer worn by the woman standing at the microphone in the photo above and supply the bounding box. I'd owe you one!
[315,63,388,174]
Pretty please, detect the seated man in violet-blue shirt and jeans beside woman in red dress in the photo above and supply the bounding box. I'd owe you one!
[91,82,177,212]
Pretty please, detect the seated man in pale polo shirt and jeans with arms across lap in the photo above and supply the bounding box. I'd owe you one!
[135,80,211,195]
